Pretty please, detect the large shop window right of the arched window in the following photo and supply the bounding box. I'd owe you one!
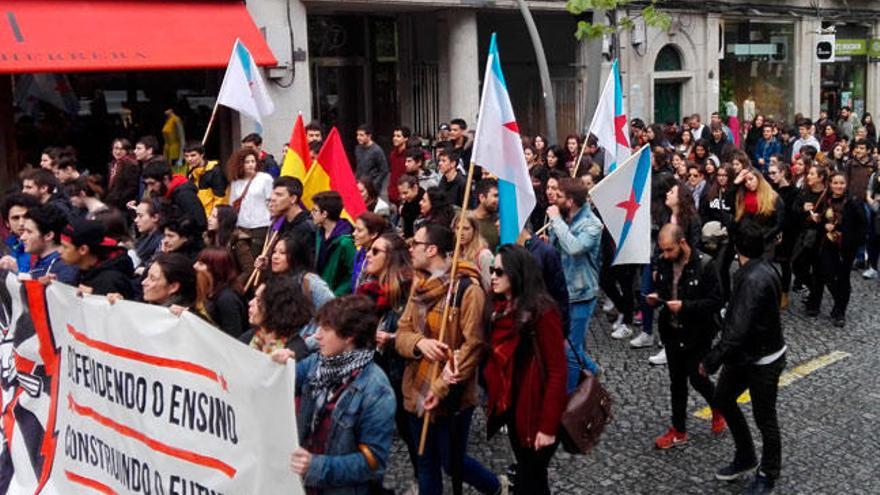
[718,20,796,120]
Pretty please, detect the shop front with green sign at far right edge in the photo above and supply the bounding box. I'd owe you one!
[821,25,871,118]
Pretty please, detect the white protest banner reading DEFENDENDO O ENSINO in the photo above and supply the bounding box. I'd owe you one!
[0,277,303,495]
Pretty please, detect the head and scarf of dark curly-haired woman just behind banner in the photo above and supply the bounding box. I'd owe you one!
[239,277,315,360]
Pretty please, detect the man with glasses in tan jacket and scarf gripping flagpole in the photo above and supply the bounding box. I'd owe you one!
[394,224,502,495]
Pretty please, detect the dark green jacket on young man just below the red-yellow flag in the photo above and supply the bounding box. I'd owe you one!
[315,218,355,297]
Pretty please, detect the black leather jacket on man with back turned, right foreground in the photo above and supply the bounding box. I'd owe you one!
[703,259,785,373]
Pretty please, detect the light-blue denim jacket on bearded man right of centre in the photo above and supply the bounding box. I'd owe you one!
[550,204,602,302]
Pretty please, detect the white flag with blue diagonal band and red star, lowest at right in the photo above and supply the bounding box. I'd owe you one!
[590,144,651,265]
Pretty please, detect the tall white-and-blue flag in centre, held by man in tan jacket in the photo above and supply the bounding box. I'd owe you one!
[471,33,535,244]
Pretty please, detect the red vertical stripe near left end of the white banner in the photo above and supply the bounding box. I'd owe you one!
[24,280,59,493]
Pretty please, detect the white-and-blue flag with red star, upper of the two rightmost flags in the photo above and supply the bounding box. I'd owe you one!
[588,60,631,174]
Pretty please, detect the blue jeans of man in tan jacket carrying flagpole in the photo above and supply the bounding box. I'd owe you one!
[407,408,501,495]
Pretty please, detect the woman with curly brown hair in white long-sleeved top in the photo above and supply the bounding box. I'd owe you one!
[226,148,273,256]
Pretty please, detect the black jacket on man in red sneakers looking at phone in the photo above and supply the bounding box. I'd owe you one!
[654,249,722,349]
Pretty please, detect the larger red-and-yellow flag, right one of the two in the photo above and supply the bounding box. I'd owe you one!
[302,127,367,222]
